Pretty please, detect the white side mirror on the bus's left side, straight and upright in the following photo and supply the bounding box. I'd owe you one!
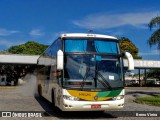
[57,50,64,70]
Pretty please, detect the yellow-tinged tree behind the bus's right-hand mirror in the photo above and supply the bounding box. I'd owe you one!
[119,37,142,59]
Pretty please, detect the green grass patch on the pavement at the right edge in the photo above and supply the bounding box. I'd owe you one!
[134,96,160,106]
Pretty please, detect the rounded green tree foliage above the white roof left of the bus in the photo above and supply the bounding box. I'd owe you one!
[8,41,48,55]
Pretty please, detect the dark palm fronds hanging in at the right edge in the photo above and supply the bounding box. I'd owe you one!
[148,16,160,50]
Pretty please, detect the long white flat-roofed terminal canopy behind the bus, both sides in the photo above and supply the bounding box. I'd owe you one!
[0,54,160,85]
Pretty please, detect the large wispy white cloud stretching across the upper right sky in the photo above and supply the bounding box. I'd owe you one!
[73,11,159,29]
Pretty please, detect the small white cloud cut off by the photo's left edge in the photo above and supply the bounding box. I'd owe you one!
[0,28,19,36]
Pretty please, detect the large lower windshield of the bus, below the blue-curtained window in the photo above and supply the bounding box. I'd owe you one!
[63,54,123,90]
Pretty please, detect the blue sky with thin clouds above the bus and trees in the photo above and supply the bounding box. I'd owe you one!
[0,0,160,60]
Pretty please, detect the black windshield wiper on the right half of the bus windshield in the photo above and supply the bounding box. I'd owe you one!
[95,70,113,90]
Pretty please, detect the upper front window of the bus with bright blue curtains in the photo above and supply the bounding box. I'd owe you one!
[64,39,118,54]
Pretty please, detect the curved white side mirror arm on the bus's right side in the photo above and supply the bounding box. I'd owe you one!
[124,52,134,70]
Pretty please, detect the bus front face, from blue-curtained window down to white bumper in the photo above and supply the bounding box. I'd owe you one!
[61,38,124,111]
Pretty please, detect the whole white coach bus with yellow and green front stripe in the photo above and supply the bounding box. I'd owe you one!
[37,33,134,111]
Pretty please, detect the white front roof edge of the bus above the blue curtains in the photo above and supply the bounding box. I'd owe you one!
[61,33,118,40]
